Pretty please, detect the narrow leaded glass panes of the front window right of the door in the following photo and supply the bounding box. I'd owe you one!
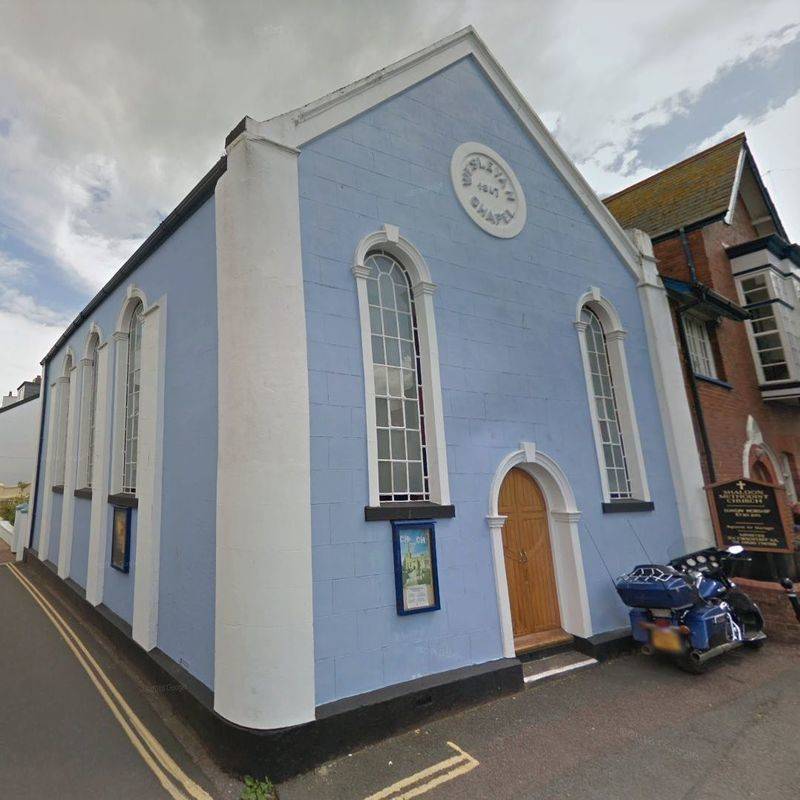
[581,307,631,500]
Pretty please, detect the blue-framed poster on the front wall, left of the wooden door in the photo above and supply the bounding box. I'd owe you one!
[392,521,439,614]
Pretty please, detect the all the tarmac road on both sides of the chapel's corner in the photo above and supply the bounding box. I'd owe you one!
[0,565,800,800]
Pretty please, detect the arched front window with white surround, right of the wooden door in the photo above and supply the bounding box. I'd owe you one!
[575,289,652,511]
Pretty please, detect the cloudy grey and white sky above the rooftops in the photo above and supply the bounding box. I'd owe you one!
[0,0,800,392]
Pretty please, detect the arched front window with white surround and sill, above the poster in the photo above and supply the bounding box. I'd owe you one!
[353,225,455,510]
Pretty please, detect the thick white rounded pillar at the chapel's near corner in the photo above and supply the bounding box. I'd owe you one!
[214,125,315,729]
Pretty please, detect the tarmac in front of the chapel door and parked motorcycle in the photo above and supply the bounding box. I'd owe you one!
[279,642,800,800]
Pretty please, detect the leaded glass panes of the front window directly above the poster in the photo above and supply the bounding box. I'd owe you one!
[364,251,430,502]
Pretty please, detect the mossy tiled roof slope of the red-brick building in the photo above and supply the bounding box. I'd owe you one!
[603,133,747,238]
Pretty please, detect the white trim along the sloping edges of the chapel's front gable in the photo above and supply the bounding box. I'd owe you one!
[257,26,639,278]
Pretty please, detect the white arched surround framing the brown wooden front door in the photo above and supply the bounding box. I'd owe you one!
[486,442,592,658]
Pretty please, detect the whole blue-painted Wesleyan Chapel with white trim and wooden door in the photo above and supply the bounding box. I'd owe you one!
[21,28,699,768]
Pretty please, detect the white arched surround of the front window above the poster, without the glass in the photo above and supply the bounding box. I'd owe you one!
[353,225,450,506]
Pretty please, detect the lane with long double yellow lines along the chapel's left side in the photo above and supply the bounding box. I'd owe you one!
[0,565,222,800]
